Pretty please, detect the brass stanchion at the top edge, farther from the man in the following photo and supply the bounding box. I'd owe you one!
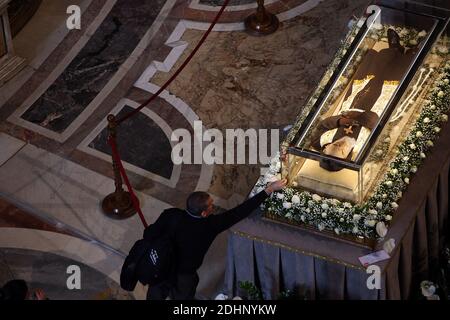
[245,0,280,36]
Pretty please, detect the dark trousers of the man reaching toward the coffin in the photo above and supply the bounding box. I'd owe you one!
[147,273,199,300]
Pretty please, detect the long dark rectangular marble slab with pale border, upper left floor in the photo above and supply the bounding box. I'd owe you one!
[22,0,165,133]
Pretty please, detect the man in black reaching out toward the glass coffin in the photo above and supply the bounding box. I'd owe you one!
[144,180,286,300]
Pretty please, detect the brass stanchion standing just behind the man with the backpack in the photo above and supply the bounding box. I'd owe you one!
[102,115,136,220]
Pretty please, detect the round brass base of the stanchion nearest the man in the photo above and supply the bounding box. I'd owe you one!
[102,191,137,220]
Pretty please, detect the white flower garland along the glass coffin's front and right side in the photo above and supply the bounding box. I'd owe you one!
[253,63,450,238]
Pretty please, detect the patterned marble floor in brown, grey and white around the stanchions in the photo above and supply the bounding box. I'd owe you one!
[0,0,368,299]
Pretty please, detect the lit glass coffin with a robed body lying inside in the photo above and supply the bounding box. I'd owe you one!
[282,1,448,203]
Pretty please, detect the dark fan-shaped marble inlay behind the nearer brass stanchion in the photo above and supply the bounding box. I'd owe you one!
[89,106,173,179]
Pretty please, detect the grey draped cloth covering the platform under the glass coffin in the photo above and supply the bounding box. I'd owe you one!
[225,124,450,300]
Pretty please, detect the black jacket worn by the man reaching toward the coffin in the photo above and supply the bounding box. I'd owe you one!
[144,191,268,274]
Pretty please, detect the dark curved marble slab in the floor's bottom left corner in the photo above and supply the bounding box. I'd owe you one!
[0,248,133,300]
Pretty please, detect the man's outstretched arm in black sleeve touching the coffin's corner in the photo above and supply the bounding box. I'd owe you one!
[211,180,286,233]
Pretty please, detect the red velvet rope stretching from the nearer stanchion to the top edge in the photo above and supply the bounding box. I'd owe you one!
[117,0,230,125]
